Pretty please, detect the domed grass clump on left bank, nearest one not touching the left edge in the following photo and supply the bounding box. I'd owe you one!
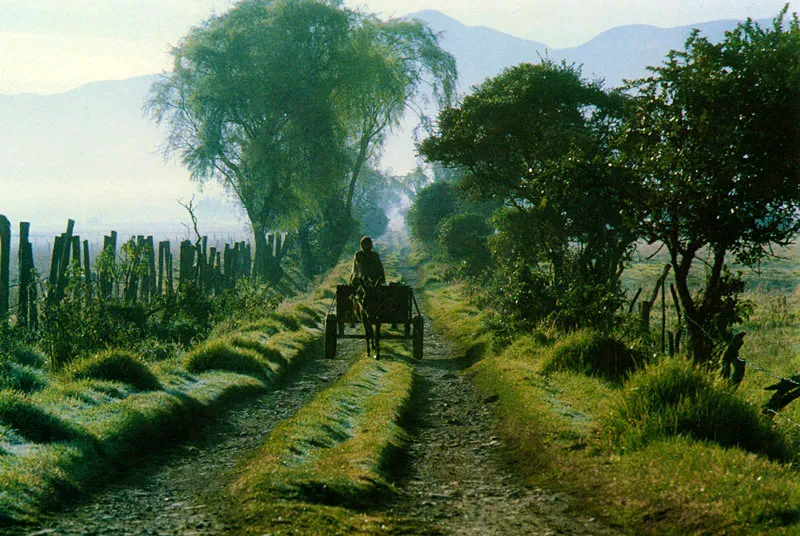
[67,350,161,391]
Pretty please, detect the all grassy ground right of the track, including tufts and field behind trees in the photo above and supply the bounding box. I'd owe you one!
[425,244,800,534]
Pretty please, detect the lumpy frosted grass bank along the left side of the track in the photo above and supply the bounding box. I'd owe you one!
[0,270,342,526]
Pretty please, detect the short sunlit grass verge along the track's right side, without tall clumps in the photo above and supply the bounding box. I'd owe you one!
[426,284,800,534]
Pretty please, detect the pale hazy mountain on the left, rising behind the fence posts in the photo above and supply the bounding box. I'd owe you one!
[0,75,242,233]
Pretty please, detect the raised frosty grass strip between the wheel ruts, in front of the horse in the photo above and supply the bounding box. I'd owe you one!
[225,348,414,534]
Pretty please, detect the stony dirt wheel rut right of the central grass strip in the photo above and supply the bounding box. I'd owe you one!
[382,314,617,535]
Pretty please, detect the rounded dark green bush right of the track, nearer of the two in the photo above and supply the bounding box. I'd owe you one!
[438,214,492,275]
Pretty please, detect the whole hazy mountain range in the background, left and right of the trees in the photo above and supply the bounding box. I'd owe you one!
[0,11,769,232]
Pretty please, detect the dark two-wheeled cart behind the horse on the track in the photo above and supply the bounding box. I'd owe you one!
[325,283,424,359]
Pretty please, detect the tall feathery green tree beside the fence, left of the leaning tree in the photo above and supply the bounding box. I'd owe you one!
[147,0,352,278]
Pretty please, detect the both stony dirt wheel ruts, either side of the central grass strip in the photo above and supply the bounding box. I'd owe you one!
[0,278,614,536]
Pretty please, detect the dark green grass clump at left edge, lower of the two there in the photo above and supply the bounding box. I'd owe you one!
[0,390,81,443]
